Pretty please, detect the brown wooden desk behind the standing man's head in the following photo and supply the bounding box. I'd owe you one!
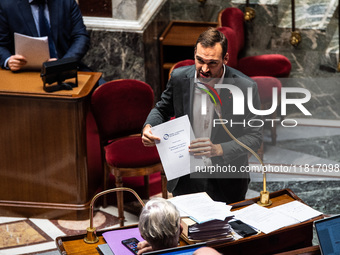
[159,21,217,91]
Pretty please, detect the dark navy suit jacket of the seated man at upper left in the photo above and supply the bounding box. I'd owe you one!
[0,0,89,67]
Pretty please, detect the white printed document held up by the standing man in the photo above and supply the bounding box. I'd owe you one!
[151,115,204,180]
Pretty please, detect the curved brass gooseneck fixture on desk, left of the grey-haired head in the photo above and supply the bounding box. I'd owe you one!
[84,187,144,244]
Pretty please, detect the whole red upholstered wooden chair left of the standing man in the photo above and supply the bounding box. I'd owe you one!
[91,79,167,226]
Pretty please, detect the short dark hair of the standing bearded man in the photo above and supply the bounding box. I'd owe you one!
[195,27,228,58]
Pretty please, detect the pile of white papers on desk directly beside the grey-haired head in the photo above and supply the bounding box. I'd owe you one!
[169,192,233,224]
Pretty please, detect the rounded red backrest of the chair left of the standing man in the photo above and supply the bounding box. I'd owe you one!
[91,79,154,142]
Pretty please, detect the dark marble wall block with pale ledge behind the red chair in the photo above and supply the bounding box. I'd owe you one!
[84,0,170,99]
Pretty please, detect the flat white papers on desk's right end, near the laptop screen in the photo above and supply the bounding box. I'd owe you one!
[233,201,322,234]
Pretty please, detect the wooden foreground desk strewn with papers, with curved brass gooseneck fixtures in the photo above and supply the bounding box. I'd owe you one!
[56,189,322,255]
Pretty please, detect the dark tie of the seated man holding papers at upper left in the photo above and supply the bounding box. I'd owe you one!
[32,0,57,58]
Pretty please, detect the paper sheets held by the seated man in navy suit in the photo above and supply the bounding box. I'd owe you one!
[14,33,50,70]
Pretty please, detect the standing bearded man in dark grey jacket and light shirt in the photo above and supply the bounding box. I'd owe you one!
[142,28,262,203]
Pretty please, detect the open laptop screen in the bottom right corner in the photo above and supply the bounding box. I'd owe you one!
[314,215,340,255]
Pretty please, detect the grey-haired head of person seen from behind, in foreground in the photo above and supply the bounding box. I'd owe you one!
[137,198,182,254]
